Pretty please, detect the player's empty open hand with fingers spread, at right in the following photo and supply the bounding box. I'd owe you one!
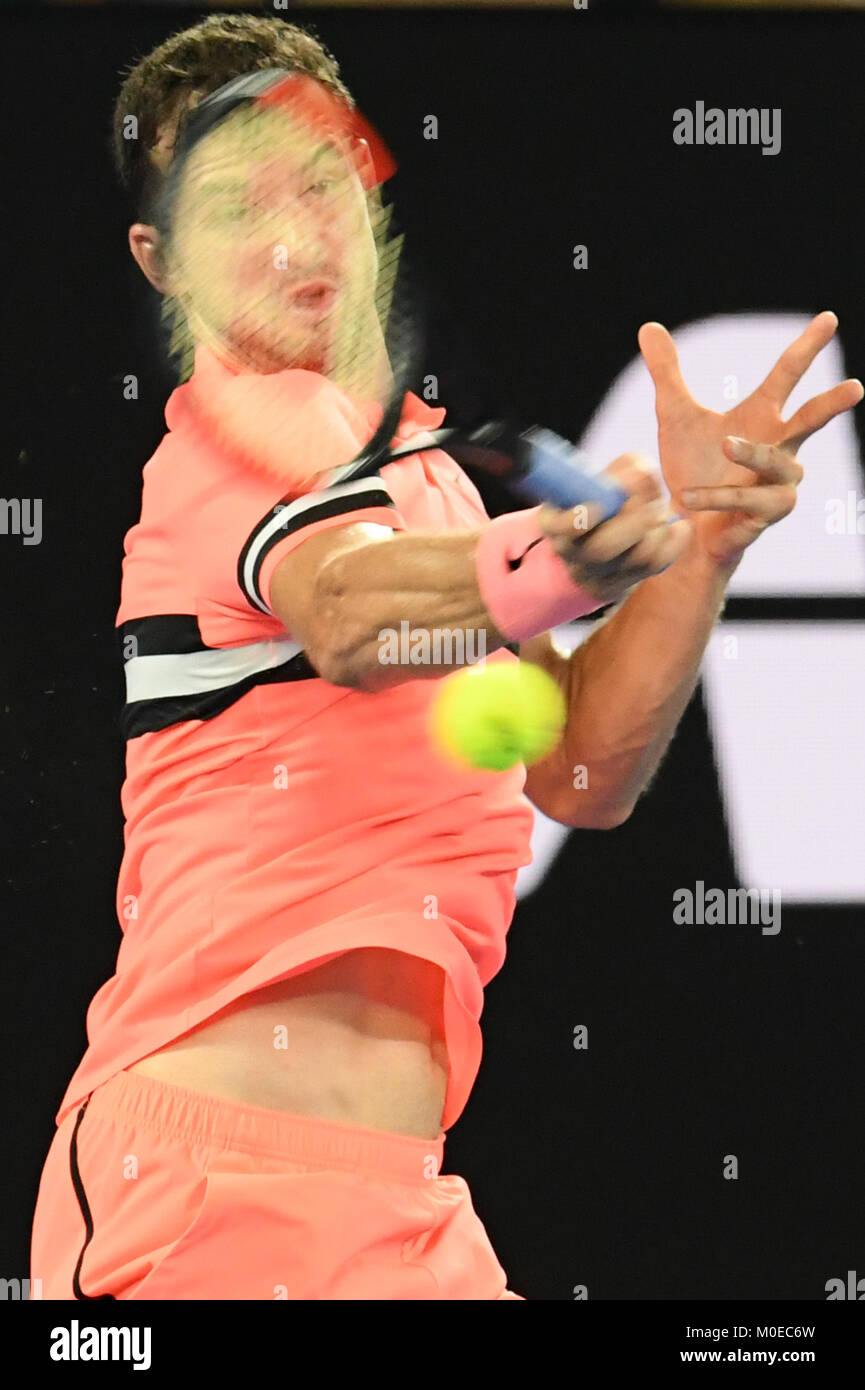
[637,311,865,566]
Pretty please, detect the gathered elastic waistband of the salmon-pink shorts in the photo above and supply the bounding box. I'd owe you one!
[89,1072,445,1182]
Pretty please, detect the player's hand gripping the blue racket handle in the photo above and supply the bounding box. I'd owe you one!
[538,453,693,603]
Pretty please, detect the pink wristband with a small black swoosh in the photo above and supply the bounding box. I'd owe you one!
[476,507,604,642]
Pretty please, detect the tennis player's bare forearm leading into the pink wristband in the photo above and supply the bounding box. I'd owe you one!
[314,531,505,692]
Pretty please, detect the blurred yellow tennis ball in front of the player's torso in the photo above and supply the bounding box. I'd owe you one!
[430,662,567,771]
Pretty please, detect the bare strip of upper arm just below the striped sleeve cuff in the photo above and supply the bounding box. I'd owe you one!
[270,521,394,666]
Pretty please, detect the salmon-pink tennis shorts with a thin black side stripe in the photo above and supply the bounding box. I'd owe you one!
[31,1072,522,1300]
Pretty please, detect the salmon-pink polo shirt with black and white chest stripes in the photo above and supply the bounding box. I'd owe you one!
[57,344,533,1129]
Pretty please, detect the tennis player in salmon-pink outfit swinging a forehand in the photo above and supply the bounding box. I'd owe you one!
[32,15,862,1300]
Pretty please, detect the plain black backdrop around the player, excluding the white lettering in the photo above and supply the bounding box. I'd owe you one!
[0,7,865,1300]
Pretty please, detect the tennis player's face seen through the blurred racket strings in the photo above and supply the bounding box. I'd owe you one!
[167,108,377,374]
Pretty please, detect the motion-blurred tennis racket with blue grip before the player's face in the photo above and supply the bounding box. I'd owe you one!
[154,68,645,520]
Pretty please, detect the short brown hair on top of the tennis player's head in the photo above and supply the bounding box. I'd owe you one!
[111,14,355,221]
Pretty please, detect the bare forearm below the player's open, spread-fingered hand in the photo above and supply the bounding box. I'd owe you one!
[551,530,736,826]
